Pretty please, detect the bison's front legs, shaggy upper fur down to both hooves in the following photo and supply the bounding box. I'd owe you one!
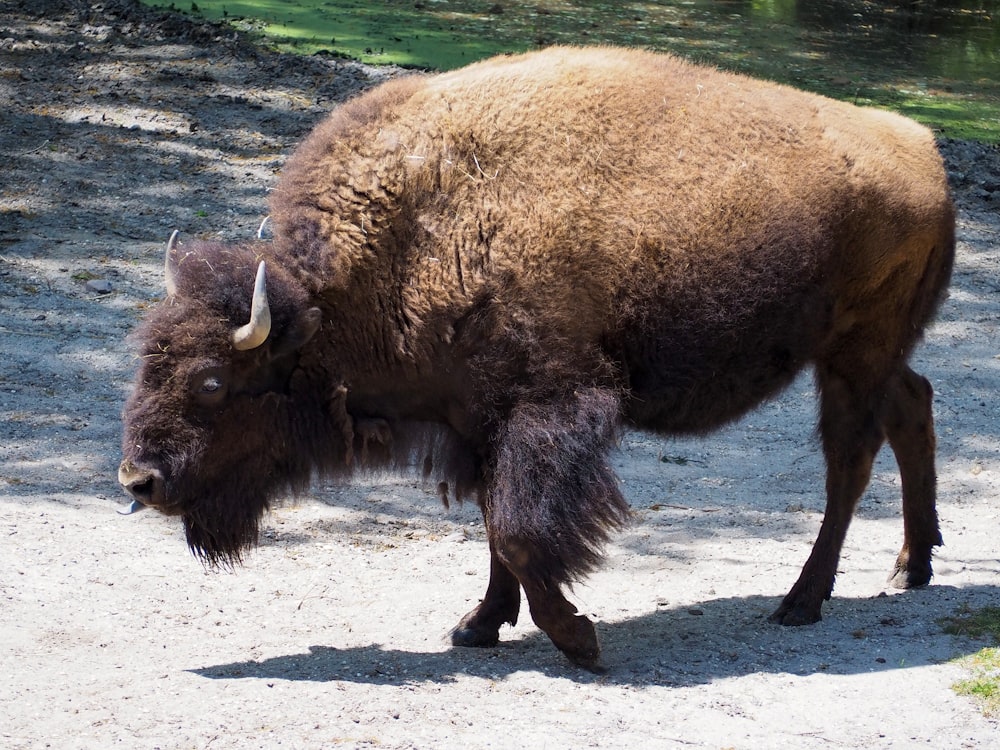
[459,388,629,669]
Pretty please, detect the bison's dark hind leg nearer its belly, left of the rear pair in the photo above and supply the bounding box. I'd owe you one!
[770,367,884,625]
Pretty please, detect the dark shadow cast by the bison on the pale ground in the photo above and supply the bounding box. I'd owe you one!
[188,586,1000,687]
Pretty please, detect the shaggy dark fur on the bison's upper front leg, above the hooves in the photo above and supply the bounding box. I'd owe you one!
[485,388,630,586]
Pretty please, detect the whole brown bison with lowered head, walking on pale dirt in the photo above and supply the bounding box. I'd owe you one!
[119,48,954,668]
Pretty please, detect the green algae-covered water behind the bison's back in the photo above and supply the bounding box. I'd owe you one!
[144,0,1000,141]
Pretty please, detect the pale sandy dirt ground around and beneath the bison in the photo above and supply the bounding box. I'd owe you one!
[0,0,1000,750]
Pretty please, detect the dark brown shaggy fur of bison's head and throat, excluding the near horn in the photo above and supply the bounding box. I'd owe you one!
[119,242,481,564]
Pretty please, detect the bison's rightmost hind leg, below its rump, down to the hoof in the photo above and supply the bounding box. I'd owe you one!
[884,367,943,589]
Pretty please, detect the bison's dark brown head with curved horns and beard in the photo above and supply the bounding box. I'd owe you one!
[118,233,328,563]
